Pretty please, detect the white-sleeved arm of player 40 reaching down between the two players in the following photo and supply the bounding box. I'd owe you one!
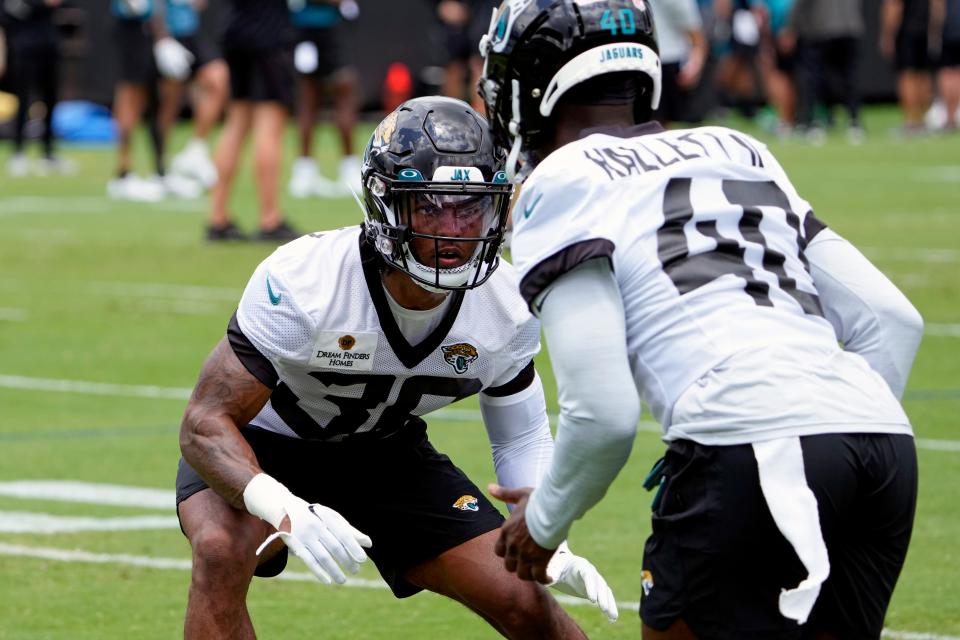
[526,260,640,549]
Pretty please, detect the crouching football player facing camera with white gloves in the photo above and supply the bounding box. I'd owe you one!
[177,98,617,639]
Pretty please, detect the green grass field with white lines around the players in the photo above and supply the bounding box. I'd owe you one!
[0,110,960,640]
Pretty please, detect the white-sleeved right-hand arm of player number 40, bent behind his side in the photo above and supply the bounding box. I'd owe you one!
[804,221,923,398]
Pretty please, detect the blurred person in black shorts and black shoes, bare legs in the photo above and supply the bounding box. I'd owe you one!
[207,0,300,242]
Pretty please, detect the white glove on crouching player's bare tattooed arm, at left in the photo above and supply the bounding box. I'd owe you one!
[243,473,373,584]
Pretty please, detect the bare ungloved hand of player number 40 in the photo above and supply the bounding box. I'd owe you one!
[488,484,555,584]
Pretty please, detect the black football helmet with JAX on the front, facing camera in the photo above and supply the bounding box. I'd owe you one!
[362,97,513,291]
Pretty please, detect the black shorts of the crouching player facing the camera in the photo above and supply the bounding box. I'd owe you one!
[177,420,503,598]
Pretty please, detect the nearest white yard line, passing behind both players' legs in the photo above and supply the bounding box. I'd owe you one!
[0,543,960,640]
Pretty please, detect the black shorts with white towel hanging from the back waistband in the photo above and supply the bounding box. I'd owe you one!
[640,434,917,640]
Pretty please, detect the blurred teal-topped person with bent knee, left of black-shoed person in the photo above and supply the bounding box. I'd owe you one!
[158,0,229,189]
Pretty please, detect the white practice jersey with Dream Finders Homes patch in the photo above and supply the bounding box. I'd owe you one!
[228,227,540,441]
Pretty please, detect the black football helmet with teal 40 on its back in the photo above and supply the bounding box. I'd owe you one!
[479,0,661,179]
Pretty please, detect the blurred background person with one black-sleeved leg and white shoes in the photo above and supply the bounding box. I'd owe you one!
[107,0,166,202]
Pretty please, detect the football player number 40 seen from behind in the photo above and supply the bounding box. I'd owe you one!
[480,0,923,639]
